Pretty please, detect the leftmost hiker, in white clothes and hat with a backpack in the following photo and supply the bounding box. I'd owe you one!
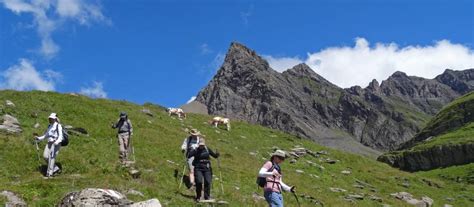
[35,113,63,178]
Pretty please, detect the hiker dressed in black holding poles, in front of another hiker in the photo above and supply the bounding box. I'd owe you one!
[188,138,219,202]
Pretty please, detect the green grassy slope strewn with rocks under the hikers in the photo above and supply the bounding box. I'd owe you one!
[0,91,474,206]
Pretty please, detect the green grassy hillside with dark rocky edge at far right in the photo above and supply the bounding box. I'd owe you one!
[378,92,474,171]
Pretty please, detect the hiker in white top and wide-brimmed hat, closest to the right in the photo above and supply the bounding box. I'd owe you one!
[258,150,295,207]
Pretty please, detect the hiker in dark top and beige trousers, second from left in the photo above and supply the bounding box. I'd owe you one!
[112,112,133,164]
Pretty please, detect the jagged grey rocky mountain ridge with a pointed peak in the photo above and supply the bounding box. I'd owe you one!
[185,43,474,156]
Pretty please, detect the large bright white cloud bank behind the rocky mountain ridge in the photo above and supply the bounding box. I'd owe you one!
[267,38,474,88]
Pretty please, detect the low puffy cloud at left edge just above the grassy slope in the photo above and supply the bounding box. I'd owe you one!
[0,59,62,91]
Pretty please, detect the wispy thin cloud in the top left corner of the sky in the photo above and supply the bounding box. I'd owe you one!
[0,0,110,59]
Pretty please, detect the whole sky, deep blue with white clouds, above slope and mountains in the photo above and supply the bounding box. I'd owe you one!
[0,0,474,106]
